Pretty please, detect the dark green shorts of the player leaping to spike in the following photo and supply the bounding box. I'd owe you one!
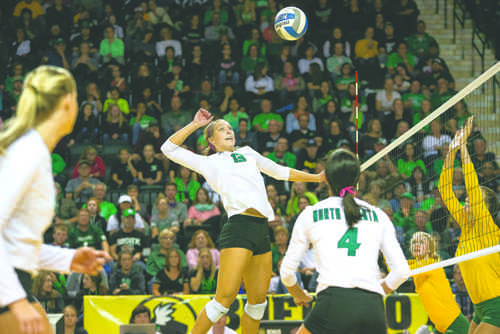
[219,215,271,255]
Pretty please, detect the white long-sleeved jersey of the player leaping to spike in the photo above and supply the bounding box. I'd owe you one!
[161,140,290,220]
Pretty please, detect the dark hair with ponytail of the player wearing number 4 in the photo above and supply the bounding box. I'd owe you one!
[325,149,361,228]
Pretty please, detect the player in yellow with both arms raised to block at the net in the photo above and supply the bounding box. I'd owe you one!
[439,117,500,334]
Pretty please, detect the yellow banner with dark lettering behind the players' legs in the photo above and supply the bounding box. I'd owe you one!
[84,294,428,334]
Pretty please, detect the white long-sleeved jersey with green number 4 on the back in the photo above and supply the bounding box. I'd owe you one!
[281,197,410,295]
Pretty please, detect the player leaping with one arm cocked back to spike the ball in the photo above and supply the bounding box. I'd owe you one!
[162,109,324,334]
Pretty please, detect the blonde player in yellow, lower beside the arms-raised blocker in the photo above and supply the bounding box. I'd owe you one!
[408,232,469,334]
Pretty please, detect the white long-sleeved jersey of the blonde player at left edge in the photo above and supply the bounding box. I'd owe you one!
[0,130,75,307]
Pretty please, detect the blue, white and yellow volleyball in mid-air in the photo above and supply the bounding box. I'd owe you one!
[274,7,307,41]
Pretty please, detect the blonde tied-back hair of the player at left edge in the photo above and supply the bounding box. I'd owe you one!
[0,66,76,154]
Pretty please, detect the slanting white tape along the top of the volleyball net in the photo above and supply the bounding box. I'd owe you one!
[361,61,500,172]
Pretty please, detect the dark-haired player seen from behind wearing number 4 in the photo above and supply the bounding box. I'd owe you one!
[281,149,410,334]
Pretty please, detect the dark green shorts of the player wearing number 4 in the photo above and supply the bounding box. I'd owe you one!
[304,287,387,334]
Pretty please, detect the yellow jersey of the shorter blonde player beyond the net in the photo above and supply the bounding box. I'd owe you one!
[408,260,461,333]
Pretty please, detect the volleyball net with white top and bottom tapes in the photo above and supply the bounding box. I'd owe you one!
[360,62,500,275]
